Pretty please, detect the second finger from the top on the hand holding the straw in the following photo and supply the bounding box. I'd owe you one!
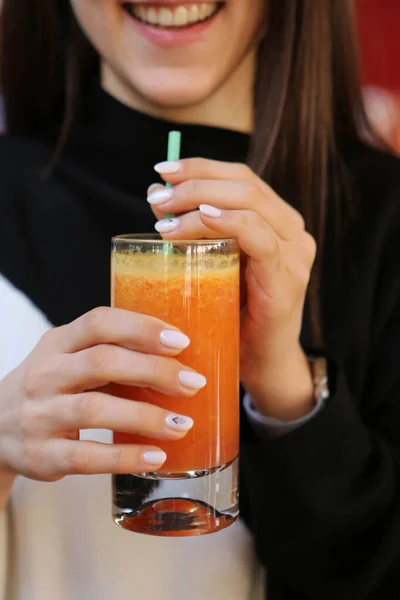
[148,179,304,240]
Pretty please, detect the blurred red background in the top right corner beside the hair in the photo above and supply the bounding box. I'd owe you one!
[0,0,400,155]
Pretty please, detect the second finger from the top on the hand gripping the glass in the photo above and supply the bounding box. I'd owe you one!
[31,345,206,397]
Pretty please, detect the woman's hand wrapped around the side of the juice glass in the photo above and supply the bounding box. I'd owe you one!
[0,308,206,481]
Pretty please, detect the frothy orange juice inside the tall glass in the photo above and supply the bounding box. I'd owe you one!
[112,244,239,474]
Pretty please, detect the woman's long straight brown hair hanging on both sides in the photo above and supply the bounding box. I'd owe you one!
[0,0,376,340]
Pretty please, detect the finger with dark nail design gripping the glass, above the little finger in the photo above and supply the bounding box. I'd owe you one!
[46,392,193,440]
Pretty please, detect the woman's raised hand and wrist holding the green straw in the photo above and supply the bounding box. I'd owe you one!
[148,158,316,420]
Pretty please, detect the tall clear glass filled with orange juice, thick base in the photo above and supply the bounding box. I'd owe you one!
[111,235,240,536]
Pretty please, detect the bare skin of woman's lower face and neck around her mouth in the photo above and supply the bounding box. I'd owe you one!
[71,0,266,131]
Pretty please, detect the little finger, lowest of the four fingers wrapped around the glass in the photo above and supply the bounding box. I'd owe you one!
[45,439,167,475]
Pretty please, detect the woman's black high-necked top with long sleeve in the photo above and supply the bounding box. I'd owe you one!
[0,85,400,600]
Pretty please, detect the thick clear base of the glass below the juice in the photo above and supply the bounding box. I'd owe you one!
[113,458,239,537]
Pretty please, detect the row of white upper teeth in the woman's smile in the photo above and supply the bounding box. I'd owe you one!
[122,2,224,29]
